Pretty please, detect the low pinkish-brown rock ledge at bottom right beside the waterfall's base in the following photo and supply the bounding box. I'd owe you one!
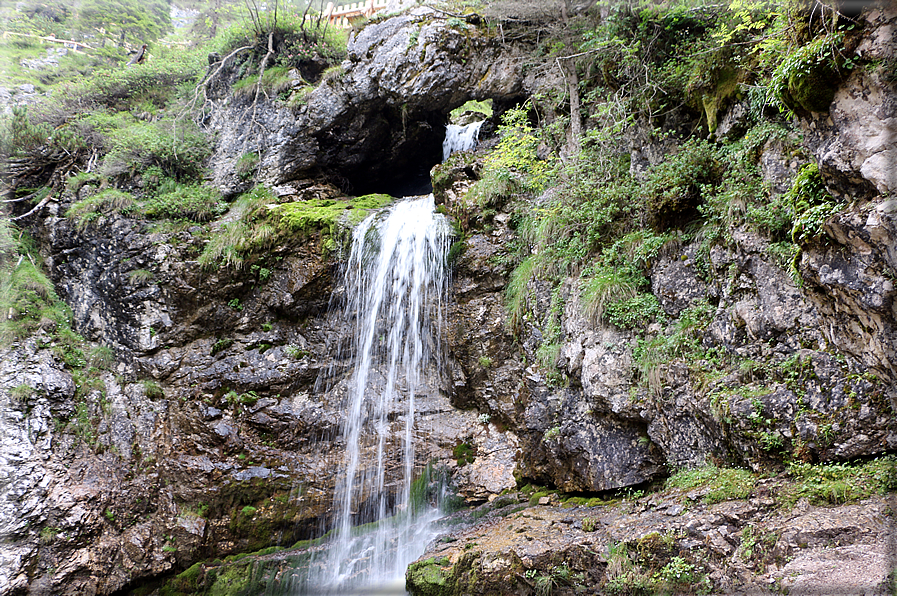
[406,480,890,596]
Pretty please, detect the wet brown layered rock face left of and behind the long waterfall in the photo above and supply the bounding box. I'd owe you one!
[0,180,490,594]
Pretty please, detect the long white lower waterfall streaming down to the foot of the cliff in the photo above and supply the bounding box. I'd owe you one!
[308,195,450,594]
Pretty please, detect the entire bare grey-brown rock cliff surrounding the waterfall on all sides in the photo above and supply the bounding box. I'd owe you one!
[0,2,897,594]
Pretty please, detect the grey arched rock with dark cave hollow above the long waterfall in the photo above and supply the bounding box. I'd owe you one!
[210,8,523,194]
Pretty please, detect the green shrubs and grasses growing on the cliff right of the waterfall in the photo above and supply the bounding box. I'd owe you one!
[434,2,883,470]
